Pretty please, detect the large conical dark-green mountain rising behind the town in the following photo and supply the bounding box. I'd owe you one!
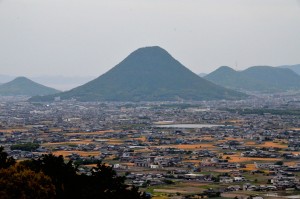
[31,46,246,101]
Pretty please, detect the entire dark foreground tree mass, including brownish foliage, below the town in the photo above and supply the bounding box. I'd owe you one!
[0,147,148,199]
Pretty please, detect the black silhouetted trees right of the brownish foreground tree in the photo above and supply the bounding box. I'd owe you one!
[26,154,147,199]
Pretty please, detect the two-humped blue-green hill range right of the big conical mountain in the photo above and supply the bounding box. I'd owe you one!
[204,66,300,92]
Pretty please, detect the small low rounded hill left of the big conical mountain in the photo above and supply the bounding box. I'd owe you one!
[0,77,60,96]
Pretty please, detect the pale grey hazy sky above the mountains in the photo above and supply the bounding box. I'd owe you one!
[0,0,300,76]
